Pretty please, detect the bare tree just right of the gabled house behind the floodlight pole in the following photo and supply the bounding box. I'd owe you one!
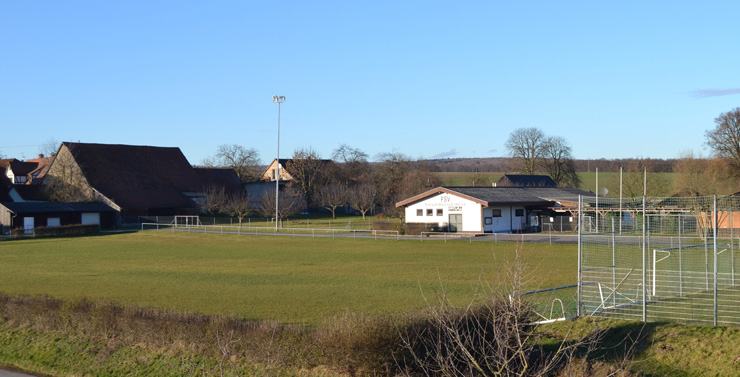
[285,148,327,209]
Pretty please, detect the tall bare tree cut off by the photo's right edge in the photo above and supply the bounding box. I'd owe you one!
[704,107,740,176]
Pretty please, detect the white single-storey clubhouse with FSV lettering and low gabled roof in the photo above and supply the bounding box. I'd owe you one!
[396,187,593,233]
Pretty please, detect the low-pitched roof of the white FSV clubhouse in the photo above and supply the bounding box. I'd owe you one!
[396,187,594,207]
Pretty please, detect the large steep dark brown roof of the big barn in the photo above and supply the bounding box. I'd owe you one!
[57,142,203,209]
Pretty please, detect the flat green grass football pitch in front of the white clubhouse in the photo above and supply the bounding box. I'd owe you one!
[0,232,577,323]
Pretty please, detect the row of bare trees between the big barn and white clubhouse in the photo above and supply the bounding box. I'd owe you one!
[202,144,441,221]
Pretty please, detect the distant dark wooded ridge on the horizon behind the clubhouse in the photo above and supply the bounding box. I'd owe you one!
[426,157,678,173]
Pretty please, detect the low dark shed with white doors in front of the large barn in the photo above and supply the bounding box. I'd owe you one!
[0,202,116,233]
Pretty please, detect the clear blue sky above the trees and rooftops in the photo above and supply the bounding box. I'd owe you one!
[0,0,740,164]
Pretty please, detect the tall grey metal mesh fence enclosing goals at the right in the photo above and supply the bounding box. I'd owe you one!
[578,196,740,325]
